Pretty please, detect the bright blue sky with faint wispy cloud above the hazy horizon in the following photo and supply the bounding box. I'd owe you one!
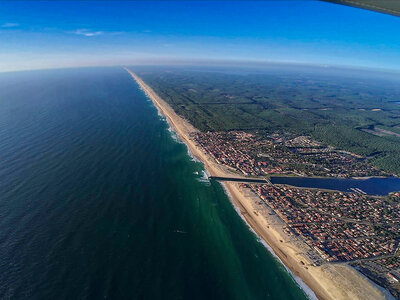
[0,1,400,71]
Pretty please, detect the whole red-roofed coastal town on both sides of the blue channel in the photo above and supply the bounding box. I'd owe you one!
[192,131,400,295]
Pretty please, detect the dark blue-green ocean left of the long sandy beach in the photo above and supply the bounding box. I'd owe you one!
[0,68,305,299]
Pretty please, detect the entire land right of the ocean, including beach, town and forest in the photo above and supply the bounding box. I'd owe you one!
[129,65,400,299]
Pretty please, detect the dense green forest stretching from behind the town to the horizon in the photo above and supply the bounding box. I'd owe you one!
[137,68,400,174]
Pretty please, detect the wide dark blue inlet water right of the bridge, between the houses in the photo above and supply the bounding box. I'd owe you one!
[270,176,400,196]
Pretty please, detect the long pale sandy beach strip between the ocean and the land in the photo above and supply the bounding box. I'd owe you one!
[125,68,385,299]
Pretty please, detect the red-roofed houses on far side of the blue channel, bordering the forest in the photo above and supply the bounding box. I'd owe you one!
[193,131,385,178]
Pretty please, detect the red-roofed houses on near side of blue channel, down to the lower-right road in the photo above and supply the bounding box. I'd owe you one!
[249,184,400,262]
